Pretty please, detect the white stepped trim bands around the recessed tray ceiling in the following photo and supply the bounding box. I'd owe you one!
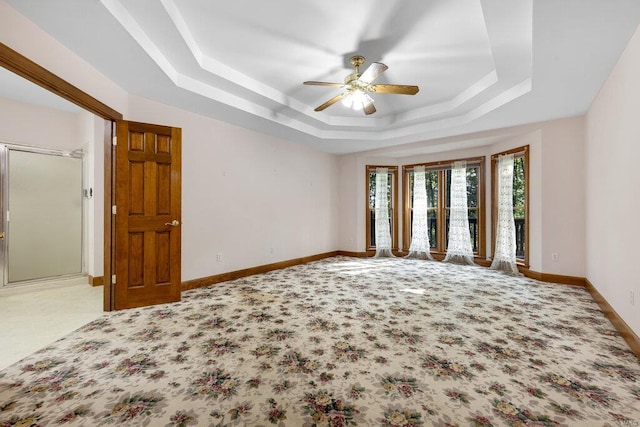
[101,0,532,141]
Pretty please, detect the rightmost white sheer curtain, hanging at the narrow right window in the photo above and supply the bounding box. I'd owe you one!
[491,154,518,274]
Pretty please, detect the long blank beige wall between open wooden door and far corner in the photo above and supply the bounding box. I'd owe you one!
[128,97,339,280]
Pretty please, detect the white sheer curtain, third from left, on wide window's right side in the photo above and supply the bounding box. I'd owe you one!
[444,161,473,265]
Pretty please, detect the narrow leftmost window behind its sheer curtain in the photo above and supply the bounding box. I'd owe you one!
[366,165,398,254]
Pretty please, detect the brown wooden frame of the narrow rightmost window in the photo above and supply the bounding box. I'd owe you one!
[491,145,530,268]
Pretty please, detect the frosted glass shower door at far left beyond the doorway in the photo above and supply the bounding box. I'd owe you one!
[3,149,83,284]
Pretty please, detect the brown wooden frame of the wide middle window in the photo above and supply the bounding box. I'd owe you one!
[402,156,486,259]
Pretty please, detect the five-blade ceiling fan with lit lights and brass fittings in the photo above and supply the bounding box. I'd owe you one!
[304,55,419,115]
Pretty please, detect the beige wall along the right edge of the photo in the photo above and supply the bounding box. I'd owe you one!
[585,24,640,335]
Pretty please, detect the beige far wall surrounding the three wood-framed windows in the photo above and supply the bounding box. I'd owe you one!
[339,118,585,277]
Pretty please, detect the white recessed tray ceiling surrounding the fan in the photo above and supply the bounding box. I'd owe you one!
[7,0,640,153]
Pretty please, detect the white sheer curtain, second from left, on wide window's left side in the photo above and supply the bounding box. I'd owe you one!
[407,166,433,259]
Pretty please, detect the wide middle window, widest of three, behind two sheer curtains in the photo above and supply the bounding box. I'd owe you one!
[402,157,485,256]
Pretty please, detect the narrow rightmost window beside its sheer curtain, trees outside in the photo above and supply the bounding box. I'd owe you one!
[491,145,529,266]
